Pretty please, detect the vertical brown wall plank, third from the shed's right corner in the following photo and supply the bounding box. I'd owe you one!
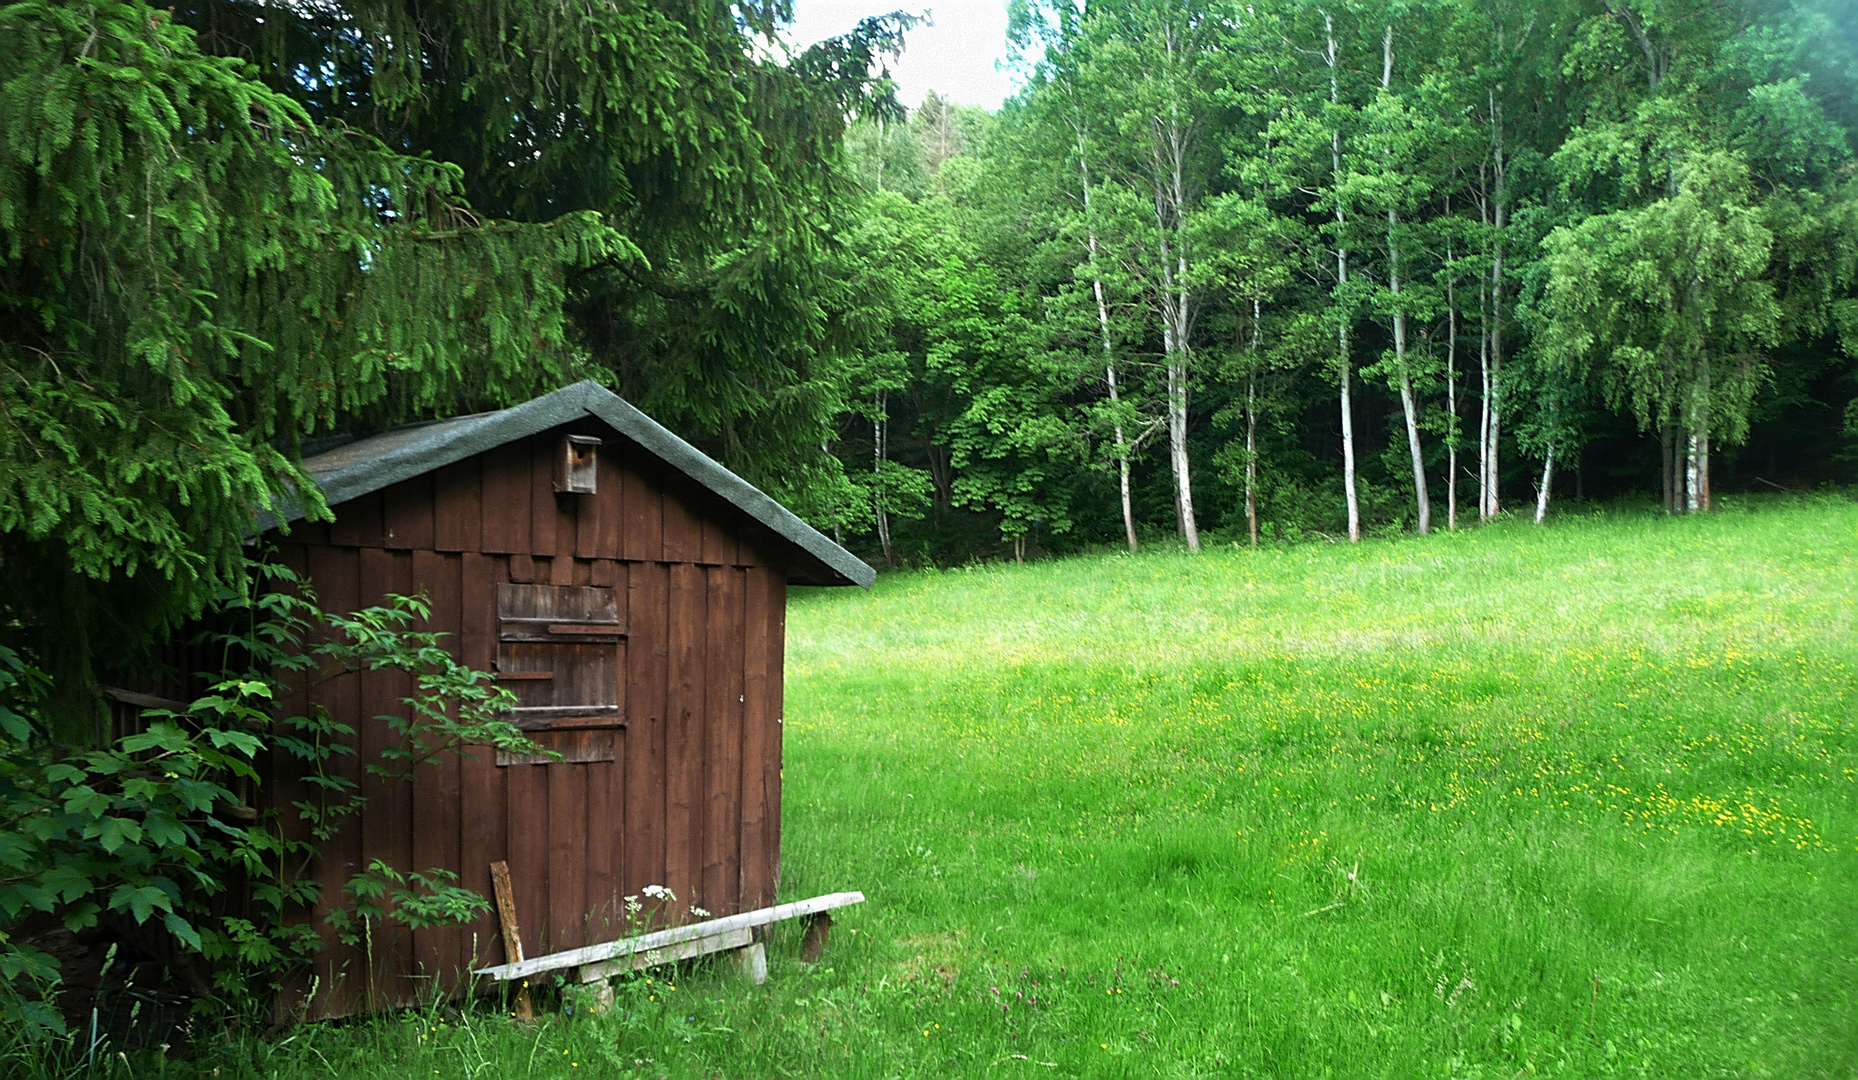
[665,563,708,903]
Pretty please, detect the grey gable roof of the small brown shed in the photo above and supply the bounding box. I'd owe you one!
[262,379,877,587]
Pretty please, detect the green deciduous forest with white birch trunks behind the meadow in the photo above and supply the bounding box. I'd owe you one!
[834,0,1858,560]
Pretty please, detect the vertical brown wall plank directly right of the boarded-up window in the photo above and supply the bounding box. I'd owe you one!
[621,563,671,892]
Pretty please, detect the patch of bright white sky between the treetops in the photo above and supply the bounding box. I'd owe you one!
[790,0,1013,110]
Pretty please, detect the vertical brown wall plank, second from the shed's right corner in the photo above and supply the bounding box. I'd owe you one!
[702,567,743,915]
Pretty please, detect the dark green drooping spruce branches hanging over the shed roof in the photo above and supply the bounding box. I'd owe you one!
[0,0,901,731]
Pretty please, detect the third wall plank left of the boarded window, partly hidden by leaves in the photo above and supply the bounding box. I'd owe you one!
[351,548,416,1004]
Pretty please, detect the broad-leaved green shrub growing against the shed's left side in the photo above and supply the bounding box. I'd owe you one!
[0,565,539,1039]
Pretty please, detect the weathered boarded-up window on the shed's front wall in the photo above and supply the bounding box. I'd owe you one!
[496,584,626,731]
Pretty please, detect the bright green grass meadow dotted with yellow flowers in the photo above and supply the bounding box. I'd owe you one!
[108,500,1858,1080]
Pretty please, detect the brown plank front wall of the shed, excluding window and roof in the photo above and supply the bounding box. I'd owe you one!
[268,422,786,1015]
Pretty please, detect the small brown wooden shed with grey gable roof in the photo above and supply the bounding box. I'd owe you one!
[268,381,873,1017]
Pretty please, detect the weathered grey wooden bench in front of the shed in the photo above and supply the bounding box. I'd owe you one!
[472,892,864,983]
